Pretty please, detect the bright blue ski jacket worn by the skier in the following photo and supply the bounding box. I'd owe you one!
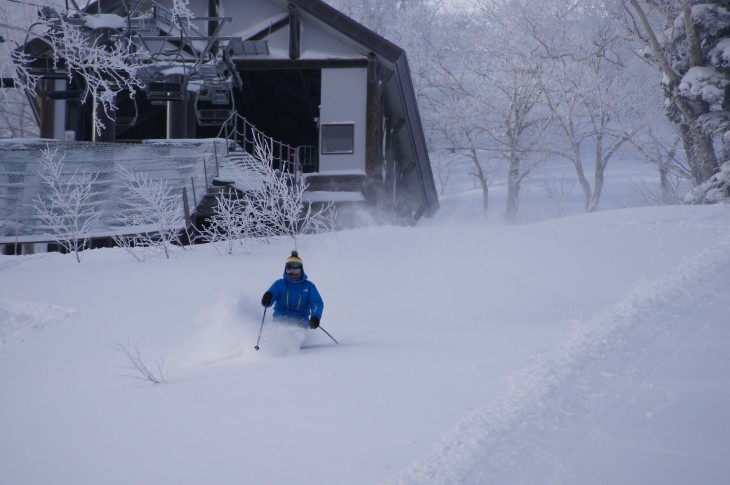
[267,272,324,325]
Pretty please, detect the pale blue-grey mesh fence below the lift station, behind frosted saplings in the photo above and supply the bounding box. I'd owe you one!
[0,139,222,244]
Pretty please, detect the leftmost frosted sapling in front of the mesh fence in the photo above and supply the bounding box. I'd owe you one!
[34,147,101,262]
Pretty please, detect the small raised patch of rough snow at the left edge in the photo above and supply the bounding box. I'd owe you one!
[0,300,76,355]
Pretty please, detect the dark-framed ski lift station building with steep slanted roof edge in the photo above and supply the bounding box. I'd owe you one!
[0,0,438,250]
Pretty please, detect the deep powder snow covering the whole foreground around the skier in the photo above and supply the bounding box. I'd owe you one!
[0,162,730,485]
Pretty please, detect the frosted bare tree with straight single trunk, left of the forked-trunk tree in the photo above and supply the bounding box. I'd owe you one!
[465,0,552,221]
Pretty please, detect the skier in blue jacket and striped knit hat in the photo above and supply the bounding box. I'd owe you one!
[261,251,324,329]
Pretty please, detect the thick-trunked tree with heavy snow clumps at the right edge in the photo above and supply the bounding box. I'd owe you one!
[623,0,730,189]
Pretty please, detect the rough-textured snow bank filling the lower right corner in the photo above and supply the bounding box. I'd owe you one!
[388,208,730,484]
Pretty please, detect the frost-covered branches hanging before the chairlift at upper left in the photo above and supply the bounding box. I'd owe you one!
[0,0,199,138]
